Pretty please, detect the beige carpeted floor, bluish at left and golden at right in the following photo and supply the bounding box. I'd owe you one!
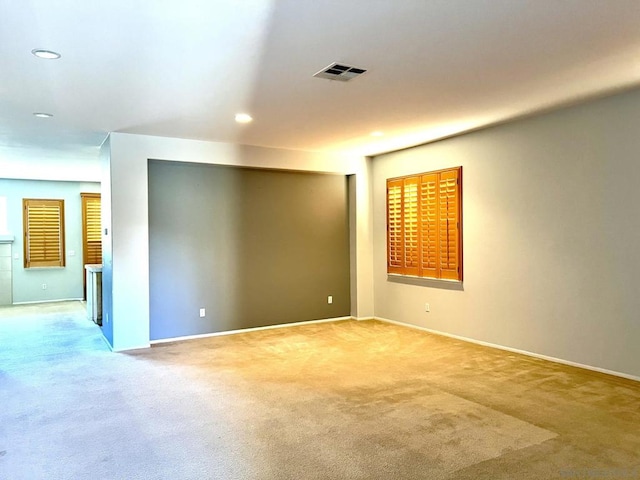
[0,302,640,480]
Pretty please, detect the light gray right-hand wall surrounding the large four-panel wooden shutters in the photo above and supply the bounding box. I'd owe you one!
[373,86,640,376]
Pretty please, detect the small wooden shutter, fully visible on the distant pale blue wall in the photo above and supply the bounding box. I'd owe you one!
[22,198,65,268]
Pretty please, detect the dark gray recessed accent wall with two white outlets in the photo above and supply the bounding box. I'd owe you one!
[148,160,351,340]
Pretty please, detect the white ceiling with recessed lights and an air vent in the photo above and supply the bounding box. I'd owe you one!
[0,0,640,163]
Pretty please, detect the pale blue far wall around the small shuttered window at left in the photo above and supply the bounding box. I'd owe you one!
[0,179,100,303]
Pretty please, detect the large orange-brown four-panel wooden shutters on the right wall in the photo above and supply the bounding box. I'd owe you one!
[387,167,462,281]
